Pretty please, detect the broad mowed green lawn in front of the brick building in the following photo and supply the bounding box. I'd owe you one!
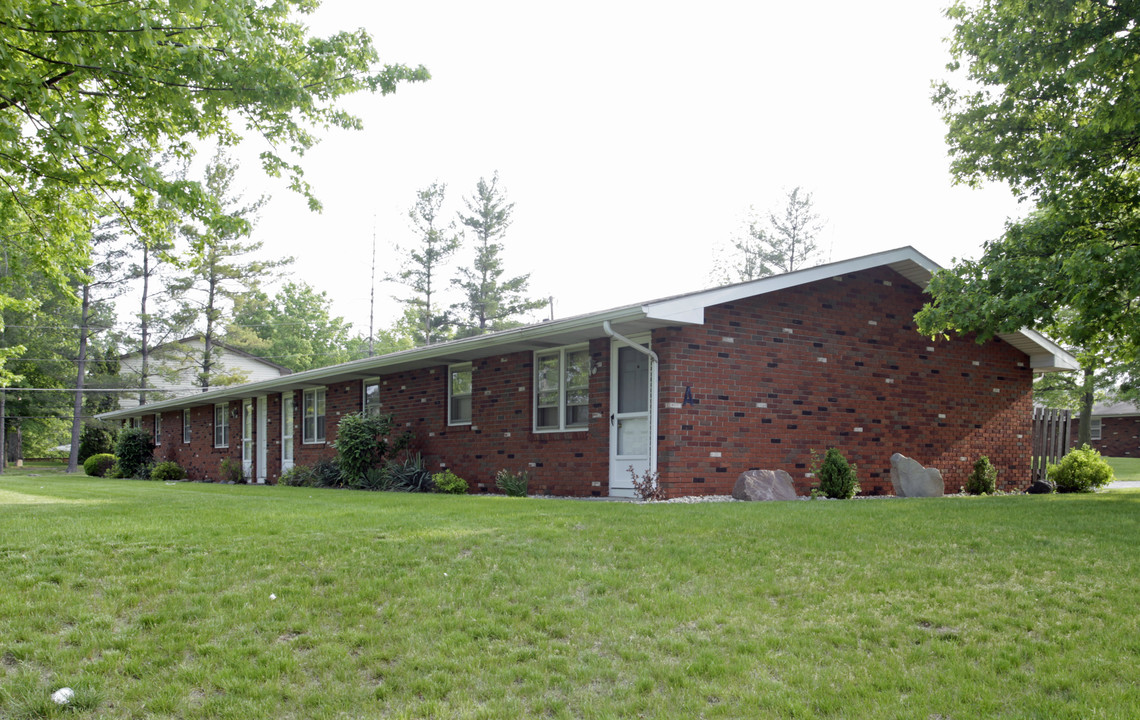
[0,476,1140,719]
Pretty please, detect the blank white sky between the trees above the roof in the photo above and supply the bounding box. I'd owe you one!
[226,0,1024,333]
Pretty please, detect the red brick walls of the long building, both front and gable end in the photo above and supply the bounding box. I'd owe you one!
[137,264,1032,496]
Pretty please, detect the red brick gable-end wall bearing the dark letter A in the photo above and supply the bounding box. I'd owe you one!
[653,269,1032,496]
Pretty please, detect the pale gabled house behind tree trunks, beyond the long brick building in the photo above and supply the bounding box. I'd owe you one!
[119,335,292,409]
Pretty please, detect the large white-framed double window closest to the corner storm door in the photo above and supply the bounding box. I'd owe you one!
[535,345,589,432]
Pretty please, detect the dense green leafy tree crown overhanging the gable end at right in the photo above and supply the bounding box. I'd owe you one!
[918,0,1140,362]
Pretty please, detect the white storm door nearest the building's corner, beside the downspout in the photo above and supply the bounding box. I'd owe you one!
[610,338,657,498]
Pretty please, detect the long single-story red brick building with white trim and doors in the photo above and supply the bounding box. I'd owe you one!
[104,247,1077,497]
